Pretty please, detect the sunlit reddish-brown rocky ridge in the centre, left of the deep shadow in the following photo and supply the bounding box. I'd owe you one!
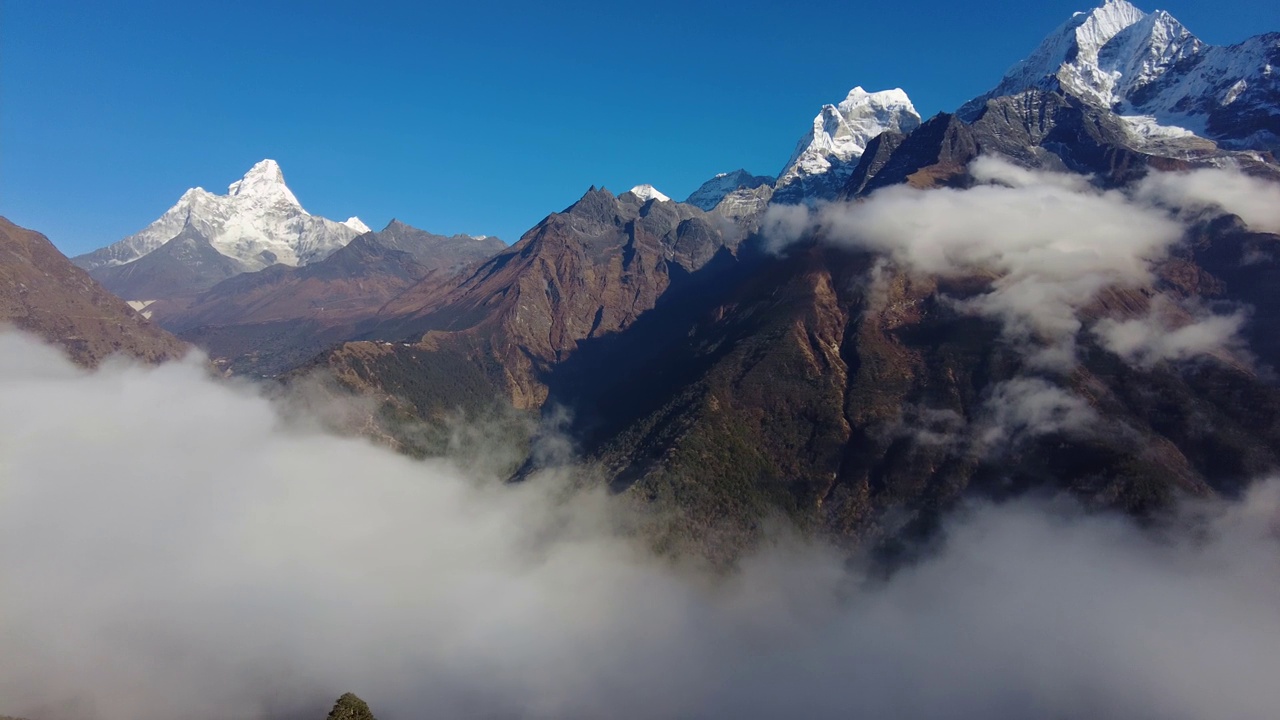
[312,188,740,415]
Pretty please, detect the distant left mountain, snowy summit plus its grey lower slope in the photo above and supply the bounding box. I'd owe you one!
[74,160,369,300]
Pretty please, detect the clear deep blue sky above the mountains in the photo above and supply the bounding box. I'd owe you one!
[0,0,1280,254]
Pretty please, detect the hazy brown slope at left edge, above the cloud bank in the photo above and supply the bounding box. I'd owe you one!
[0,218,187,366]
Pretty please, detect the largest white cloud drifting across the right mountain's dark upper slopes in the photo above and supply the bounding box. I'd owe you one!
[764,158,1183,368]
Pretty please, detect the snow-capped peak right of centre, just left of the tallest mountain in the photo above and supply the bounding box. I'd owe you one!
[774,87,920,202]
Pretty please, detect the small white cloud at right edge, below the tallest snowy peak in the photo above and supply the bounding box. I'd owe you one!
[1135,169,1280,233]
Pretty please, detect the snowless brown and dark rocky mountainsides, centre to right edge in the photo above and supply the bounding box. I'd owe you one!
[282,36,1280,548]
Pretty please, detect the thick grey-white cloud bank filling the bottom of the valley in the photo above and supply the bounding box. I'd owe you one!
[0,333,1280,720]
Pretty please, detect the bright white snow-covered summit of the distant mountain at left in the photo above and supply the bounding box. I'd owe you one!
[74,160,369,270]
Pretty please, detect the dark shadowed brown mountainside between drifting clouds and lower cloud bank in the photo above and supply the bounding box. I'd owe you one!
[548,235,1280,553]
